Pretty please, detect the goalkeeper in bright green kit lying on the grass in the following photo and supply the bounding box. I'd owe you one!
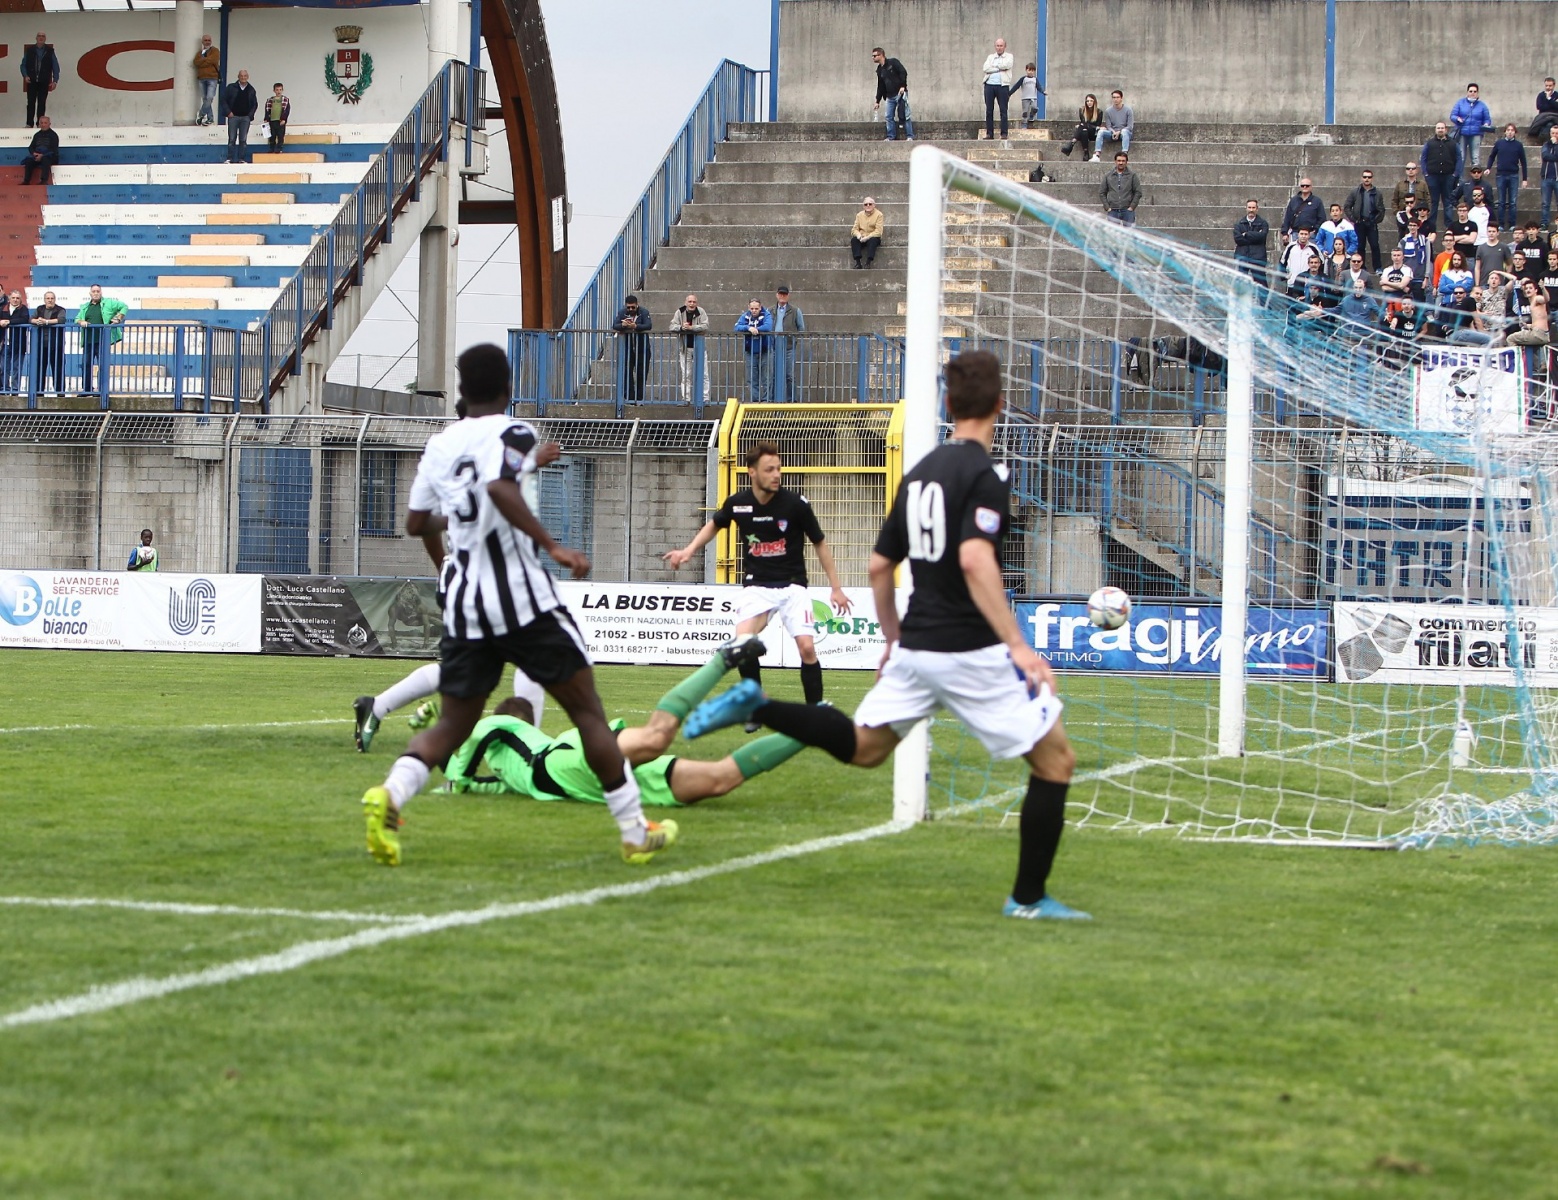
[444,637,805,807]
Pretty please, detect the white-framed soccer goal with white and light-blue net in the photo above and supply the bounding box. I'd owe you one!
[894,146,1558,846]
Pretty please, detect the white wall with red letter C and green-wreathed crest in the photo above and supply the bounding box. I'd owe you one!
[0,5,445,128]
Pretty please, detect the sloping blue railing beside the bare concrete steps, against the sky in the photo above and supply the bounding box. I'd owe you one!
[562,59,770,395]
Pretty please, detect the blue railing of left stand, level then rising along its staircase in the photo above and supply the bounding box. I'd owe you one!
[9,61,486,411]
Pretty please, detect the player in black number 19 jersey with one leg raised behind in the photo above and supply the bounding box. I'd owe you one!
[686,351,1087,919]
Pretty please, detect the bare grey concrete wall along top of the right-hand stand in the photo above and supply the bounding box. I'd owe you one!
[779,0,1558,131]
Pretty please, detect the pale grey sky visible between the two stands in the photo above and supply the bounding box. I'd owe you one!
[342,0,771,390]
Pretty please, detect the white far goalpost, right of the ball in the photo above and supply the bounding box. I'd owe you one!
[1217,288,1256,757]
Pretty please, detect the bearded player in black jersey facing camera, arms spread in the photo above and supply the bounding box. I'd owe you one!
[664,441,849,701]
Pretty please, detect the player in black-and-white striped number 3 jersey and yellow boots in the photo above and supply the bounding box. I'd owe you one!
[363,344,678,866]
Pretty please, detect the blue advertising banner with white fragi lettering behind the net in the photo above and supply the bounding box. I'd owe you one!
[1017,600,1331,679]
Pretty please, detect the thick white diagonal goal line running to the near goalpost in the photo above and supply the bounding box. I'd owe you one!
[0,821,915,1030]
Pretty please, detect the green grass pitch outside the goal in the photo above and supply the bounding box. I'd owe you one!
[0,651,1558,1200]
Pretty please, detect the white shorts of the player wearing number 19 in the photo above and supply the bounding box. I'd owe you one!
[855,645,1063,759]
